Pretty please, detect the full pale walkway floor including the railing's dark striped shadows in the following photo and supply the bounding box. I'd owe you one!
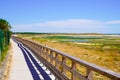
[9,40,55,80]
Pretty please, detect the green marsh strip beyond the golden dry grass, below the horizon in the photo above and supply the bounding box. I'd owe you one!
[32,35,120,51]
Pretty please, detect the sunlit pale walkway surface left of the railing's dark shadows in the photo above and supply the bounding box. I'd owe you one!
[9,40,33,80]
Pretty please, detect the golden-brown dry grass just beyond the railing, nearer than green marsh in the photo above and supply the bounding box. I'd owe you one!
[31,40,120,73]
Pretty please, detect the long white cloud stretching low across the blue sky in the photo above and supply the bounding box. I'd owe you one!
[15,19,102,27]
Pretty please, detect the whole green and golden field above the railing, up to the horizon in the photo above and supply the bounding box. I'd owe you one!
[19,34,120,73]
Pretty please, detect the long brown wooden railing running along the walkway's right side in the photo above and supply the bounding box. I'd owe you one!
[13,37,120,80]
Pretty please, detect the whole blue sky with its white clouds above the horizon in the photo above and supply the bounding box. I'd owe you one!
[0,0,120,33]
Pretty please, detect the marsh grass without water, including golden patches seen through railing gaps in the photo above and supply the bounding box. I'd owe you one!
[18,35,120,80]
